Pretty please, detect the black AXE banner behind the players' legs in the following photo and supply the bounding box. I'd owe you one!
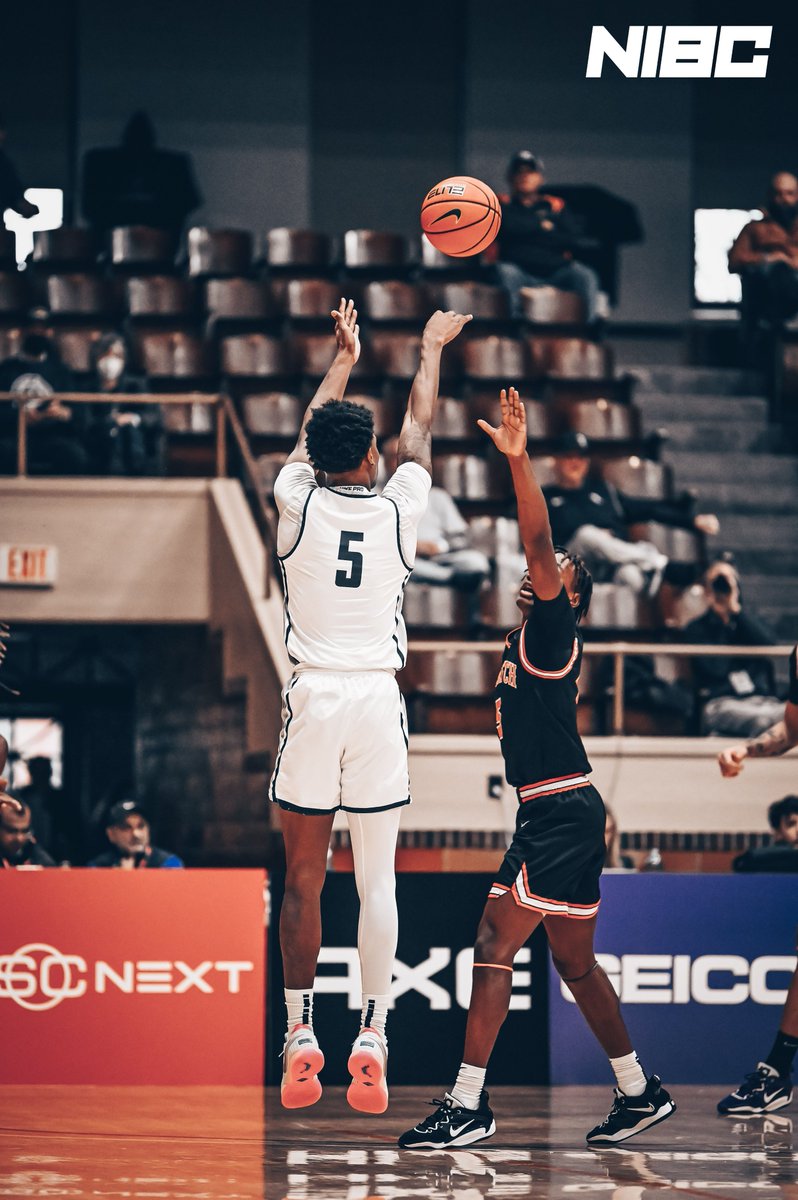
[266,873,547,1086]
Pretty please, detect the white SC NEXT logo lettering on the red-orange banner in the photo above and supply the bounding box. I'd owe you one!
[0,942,254,1013]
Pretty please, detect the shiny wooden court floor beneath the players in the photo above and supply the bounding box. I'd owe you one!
[0,1086,798,1200]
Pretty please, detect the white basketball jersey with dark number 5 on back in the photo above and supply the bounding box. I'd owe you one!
[275,463,431,671]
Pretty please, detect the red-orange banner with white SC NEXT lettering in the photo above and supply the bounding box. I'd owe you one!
[0,870,265,1085]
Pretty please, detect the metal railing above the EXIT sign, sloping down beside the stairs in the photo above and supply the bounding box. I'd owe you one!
[0,391,277,596]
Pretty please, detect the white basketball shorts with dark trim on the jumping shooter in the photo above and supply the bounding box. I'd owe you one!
[269,668,410,815]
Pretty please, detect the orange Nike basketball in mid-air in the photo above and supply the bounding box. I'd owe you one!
[421,175,502,258]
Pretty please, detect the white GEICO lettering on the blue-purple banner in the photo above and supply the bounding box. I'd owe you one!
[560,954,796,1004]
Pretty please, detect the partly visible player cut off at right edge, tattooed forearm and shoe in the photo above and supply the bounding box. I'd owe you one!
[718,646,798,1116]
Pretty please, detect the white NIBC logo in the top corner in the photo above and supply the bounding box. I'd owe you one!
[584,25,773,79]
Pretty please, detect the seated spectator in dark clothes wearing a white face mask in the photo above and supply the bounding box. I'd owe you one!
[86,334,161,475]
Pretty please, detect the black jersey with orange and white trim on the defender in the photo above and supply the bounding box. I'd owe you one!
[494,588,592,800]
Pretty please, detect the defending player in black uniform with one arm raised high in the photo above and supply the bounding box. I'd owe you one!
[398,388,676,1150]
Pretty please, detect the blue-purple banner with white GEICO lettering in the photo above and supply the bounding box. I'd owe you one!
[550,875,798,1085]
